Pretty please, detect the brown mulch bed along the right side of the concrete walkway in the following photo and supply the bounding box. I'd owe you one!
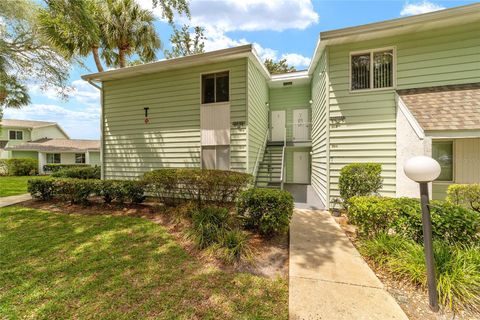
[334,214,480,320]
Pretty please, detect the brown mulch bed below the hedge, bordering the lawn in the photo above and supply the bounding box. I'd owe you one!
[18,199,289,279]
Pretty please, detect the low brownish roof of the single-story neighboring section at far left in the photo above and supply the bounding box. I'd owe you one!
[6,138,100,152]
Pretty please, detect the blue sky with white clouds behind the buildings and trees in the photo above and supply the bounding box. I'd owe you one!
[4,0,475,139]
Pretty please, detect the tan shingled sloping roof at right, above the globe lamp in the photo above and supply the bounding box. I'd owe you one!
[397,83,480,131]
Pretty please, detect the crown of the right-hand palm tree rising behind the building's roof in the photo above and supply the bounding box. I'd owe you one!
[100,0,162,68]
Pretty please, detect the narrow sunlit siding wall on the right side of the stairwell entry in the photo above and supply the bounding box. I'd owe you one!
[311,52,329,204]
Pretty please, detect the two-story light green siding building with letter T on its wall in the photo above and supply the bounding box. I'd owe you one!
[83,4,480,207]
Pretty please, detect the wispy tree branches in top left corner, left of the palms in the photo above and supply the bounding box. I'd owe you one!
[0,0,69,111]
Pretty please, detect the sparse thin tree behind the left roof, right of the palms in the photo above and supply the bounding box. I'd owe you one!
[163,25,206,59]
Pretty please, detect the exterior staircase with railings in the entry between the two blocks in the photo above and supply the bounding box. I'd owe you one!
[255,142,283,189]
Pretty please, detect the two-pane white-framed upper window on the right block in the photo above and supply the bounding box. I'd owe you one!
[350,49,395,91]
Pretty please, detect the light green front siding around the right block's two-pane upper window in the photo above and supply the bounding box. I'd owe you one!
[327,23,480,202]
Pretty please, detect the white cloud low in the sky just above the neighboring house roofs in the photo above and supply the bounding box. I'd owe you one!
[4,104,100,139]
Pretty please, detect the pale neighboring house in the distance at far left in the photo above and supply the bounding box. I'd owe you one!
[0,119,100,173]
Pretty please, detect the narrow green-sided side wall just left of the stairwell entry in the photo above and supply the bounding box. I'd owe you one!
[247,60,268,173]
